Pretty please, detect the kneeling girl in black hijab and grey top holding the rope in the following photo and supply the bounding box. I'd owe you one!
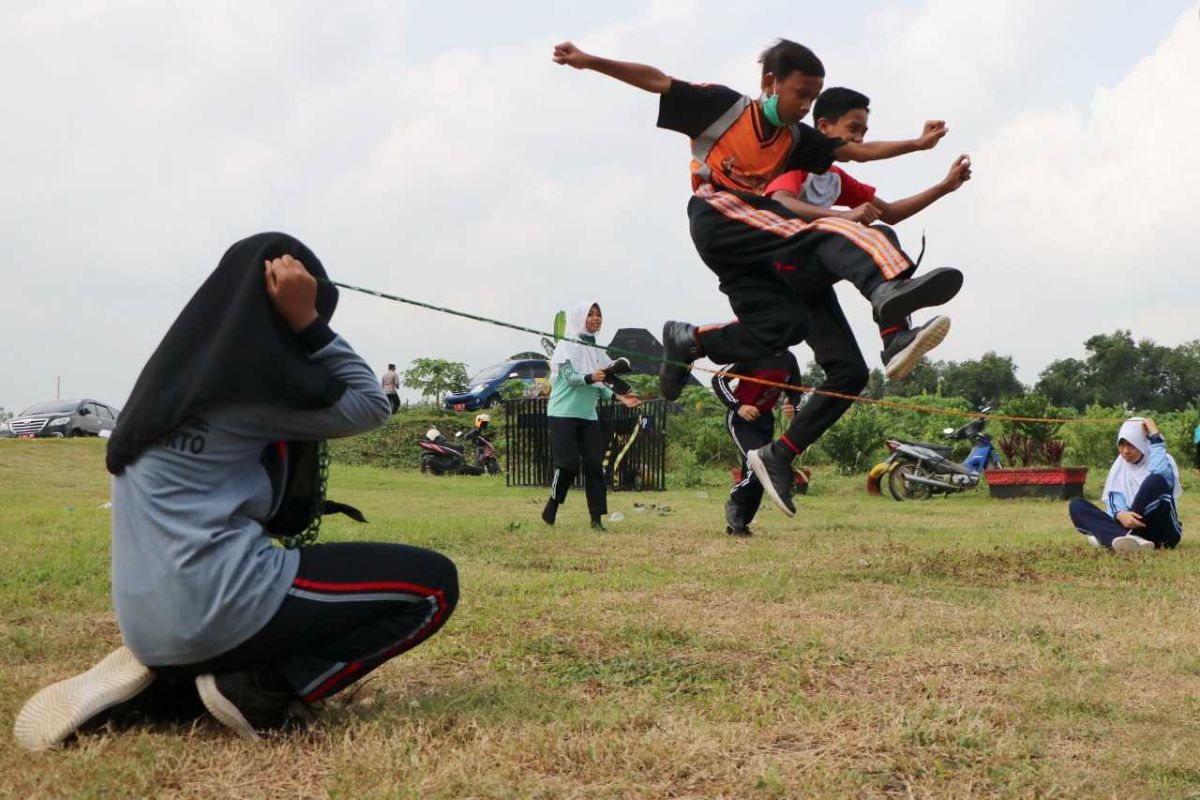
[16,234,458,750]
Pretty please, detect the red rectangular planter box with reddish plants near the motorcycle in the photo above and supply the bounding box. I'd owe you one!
[984,395,1087,500]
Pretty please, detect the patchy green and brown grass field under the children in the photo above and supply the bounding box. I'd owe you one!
[0,440,1200,800]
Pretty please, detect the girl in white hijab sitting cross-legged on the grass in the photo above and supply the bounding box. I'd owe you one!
[1069,417,1183,551]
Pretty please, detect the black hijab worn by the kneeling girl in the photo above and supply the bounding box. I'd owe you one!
[107,233,346,475]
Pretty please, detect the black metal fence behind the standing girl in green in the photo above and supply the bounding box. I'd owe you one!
[504,398,667,492]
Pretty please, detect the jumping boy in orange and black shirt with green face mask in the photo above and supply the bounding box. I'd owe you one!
[554,40,962,516]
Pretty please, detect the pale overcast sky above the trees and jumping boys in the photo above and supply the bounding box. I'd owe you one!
[0,0,1200,411]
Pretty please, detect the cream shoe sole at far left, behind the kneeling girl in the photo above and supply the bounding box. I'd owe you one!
[12,646,155,751]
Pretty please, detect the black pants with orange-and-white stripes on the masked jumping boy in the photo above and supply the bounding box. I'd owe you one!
[688,188,913,363]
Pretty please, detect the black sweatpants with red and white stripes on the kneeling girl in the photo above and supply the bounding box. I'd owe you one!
[163,542,458,703]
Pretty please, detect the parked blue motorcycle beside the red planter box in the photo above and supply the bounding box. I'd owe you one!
[866,407,1000,500]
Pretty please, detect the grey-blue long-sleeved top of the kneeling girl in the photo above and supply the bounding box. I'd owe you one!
[113,337,391,667]
